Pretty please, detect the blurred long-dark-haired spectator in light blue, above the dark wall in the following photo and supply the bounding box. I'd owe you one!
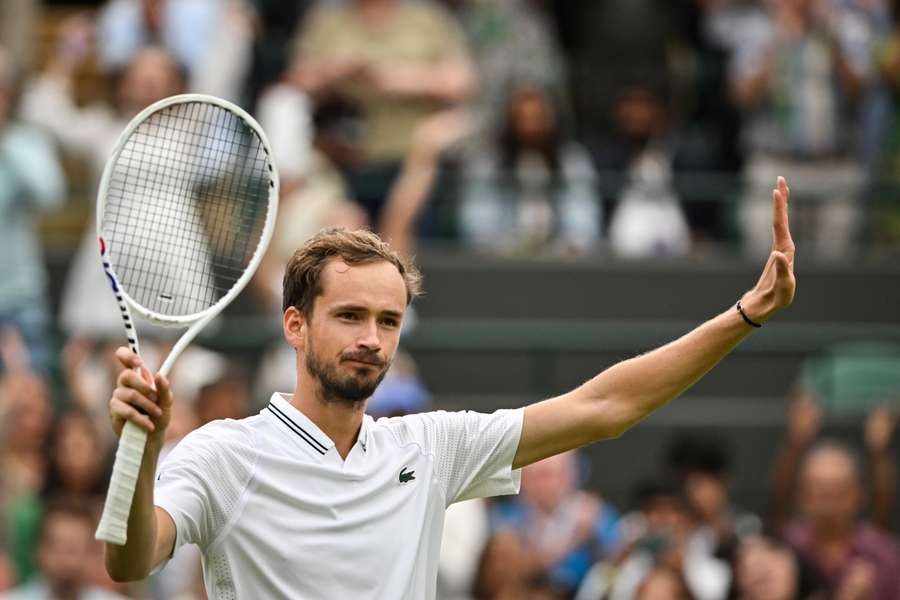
[460,83,601,254]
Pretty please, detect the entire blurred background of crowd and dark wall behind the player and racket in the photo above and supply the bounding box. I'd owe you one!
[0,0,900,600]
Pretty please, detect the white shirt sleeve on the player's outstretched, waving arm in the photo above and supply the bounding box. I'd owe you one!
[406,409,524,506]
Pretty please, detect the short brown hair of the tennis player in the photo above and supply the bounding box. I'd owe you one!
[281,228,422,318]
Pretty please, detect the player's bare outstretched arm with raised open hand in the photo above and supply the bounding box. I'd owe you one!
[513,177,796,468]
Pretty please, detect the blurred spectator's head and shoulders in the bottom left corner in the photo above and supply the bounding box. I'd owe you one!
[0,500,124,600]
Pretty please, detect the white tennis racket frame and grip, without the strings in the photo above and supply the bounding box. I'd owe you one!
[94,94,279,546]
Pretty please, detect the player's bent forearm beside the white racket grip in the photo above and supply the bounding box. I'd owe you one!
[106,438,162,581]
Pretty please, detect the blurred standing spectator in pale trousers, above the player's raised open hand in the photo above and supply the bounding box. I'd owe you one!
[732,0,871,259]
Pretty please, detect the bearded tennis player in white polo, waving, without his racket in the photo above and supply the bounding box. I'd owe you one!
[106,178,795,600]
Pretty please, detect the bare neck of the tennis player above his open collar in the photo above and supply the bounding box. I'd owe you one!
[291,374,366,458]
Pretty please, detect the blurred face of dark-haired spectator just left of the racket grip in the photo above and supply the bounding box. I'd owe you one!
[53,413,103,494]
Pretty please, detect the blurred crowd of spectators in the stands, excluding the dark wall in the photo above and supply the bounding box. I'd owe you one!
[0,0,900,600]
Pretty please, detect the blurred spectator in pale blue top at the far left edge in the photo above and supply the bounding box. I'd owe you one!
[0,48,65,373]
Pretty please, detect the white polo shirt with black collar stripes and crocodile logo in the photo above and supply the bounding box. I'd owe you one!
[155,394,523,600]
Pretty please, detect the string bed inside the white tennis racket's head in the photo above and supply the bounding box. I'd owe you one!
[102,102,272,316]
